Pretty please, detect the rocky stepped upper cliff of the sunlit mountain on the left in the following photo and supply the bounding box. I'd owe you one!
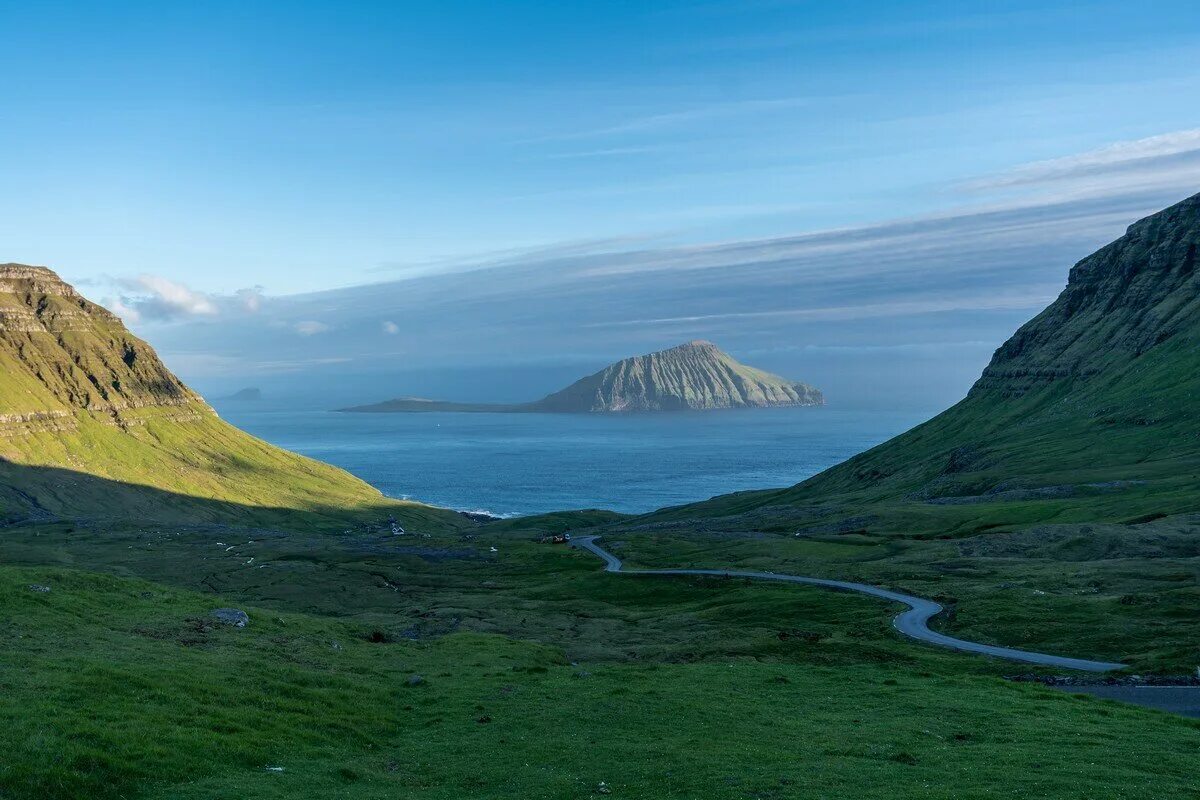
[0,264,204,434]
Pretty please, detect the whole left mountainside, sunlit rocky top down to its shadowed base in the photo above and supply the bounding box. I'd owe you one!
[0,264,453,522]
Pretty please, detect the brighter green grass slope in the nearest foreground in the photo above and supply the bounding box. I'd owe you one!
[0,555,1200,800]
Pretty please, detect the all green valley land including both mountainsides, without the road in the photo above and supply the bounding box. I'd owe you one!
[0,198,1200,800]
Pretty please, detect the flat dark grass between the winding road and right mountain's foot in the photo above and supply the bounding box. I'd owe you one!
[607,521,1200,674]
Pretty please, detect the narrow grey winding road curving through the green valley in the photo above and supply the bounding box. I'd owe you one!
[571,536,1126,672]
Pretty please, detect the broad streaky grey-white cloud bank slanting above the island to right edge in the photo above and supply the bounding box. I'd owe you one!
[131,126,1200,412]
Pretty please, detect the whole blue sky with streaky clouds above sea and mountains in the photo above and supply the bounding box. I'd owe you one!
[0,0,1200,407]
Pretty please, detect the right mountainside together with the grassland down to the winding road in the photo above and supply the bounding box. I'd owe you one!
[592,198,1200,672]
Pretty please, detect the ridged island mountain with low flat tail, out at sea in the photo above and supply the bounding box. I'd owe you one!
[342,341,824,414]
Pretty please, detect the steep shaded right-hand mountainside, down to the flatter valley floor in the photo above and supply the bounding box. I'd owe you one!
[652,190,1200,516]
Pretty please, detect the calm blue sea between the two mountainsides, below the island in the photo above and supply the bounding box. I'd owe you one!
[220,405,929,516]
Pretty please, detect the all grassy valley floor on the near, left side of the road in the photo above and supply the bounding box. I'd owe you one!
[0,525,1200,799]
